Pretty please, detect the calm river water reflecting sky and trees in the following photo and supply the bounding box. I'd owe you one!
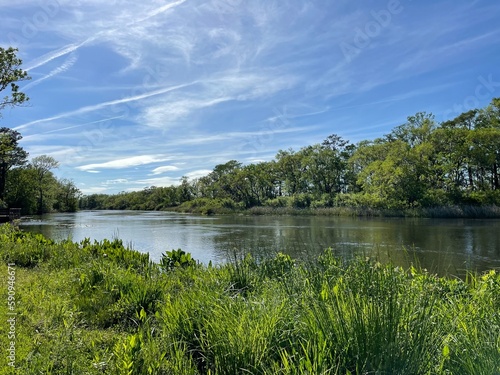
[21,211,500,276]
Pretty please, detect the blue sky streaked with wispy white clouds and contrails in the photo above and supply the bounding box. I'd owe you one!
[0,0,500,194]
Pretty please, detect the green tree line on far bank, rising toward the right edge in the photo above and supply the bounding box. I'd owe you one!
[80,98,500,210]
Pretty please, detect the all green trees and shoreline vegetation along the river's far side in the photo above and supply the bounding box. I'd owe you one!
[0,98,500,218]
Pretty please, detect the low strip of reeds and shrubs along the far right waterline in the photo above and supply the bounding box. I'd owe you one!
[169,199,500,219]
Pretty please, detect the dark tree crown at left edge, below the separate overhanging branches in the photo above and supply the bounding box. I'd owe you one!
[0,128,28,200]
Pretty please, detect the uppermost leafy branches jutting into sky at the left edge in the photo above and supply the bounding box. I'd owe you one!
[0,47,30,116]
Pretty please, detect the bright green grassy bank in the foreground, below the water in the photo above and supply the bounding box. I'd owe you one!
[0,226,500,375]
